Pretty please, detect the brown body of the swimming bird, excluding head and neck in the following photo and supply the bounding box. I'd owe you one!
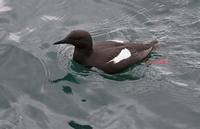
[85,41,156,73]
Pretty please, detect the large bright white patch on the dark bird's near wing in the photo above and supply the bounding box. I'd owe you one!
[108,48,131,64]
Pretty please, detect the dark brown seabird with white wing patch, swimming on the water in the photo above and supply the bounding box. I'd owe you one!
[54,30,158,74]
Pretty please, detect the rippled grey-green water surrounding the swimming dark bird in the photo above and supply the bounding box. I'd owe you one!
[0,0,200,129]
